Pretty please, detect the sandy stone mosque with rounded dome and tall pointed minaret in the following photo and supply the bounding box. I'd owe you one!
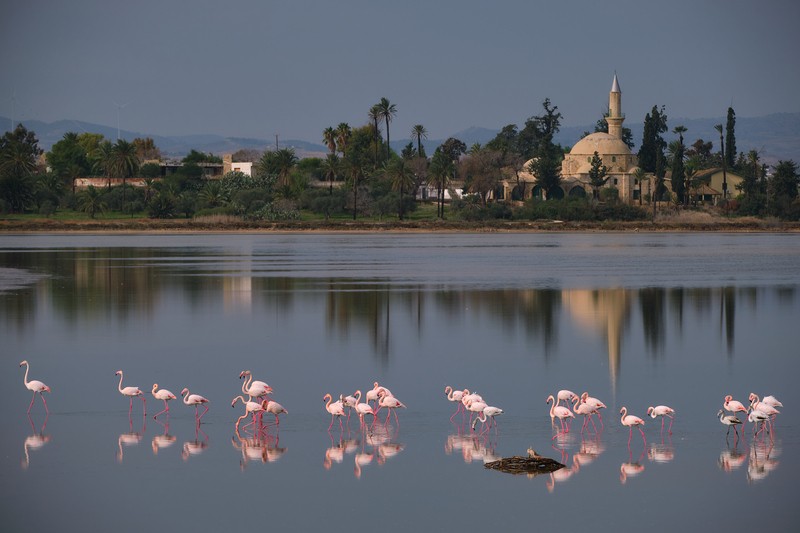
[503,74,639,203]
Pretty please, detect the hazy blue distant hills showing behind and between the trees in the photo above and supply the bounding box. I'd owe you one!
[0,113,800,164]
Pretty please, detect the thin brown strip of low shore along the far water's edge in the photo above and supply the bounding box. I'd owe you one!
[0,217,800,234]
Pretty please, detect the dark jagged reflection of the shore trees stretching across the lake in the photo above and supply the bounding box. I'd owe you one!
[0,248,796,362]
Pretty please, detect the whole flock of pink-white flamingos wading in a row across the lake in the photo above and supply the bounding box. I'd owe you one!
[19,361,783,447]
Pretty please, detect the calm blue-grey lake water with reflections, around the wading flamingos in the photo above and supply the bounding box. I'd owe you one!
[0,233,800,532]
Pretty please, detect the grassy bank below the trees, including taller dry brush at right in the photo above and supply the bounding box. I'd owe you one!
[0,211,800,233]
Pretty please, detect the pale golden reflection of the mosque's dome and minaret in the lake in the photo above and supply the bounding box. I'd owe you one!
[562,289,630,395]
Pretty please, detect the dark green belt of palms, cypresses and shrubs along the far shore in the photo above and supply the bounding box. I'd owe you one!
[0,97,800,220]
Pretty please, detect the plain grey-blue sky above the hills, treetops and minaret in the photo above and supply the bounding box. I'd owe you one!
[0,0,800,143]
